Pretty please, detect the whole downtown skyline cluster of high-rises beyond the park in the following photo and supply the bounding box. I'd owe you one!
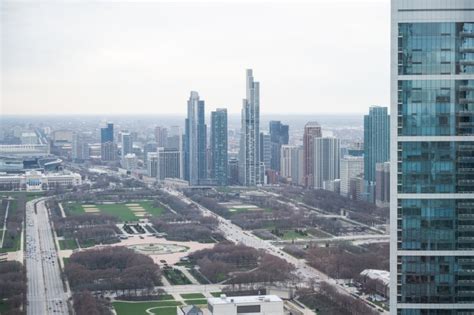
[92,69,390,206]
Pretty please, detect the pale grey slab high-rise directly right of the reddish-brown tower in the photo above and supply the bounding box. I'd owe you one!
[312,137,340,189]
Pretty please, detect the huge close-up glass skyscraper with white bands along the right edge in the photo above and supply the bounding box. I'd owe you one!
[390,0,474,315]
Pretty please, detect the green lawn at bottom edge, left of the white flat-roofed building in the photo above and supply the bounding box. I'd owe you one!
[112,301,182,315]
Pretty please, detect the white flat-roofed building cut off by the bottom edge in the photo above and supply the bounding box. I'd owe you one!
[207,295,284,315]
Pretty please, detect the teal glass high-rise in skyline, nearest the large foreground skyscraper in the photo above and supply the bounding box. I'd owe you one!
[364,106,390,184]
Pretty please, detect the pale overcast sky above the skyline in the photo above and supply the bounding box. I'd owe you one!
[0,0,390,114]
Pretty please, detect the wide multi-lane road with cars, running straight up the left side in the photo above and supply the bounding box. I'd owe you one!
[25,199,69,315]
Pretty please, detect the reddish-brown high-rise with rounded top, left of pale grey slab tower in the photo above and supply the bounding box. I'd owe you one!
[303,121,322,187]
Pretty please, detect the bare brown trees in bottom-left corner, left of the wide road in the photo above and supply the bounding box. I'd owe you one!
[0,261,26,315]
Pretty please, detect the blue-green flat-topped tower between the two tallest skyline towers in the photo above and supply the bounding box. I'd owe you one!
[210,108,228,186]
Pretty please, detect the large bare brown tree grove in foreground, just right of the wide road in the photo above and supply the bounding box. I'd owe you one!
[65,247,161,292]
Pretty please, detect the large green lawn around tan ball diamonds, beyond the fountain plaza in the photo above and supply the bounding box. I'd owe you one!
[63,201,164,221]
